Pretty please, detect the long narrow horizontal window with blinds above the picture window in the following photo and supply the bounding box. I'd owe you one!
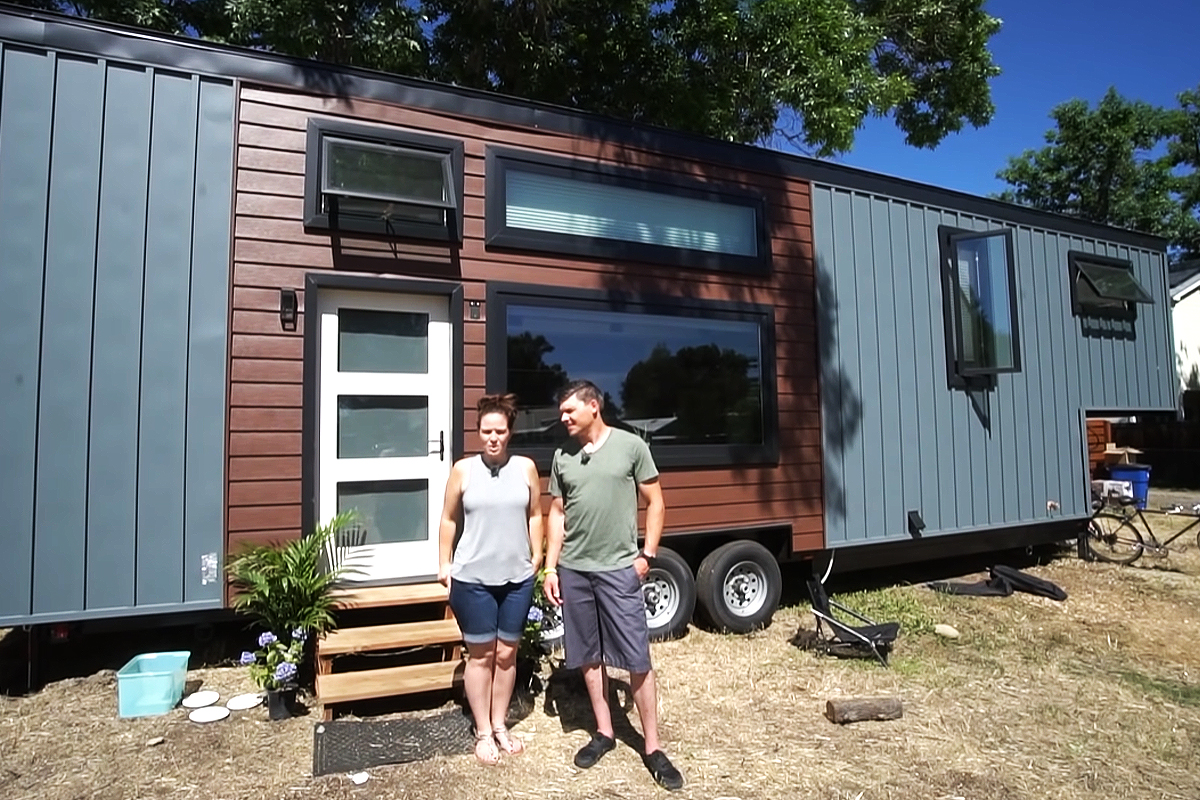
[486,148,770,272]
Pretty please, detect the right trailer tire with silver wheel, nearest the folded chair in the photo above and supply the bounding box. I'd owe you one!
[696,539,784,633]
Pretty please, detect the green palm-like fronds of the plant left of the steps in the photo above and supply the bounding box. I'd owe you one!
[226,512,354,636]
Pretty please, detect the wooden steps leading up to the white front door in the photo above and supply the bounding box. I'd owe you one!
[317,583,463,720]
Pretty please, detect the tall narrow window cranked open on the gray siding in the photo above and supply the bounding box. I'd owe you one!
[938,221,1021,378]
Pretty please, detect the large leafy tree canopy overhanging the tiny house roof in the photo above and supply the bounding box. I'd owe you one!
[17,0,1001,154]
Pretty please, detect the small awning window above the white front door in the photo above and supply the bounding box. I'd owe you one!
[305,119,463,241]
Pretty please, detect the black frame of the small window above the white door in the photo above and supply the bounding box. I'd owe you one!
[304,116,464,242]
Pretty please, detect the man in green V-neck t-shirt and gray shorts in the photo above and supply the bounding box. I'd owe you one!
[542,380,683,789]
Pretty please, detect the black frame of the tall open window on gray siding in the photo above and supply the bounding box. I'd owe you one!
[937,225,1021,389]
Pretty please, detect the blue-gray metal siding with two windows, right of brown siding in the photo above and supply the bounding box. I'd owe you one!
[812,186,1175,547]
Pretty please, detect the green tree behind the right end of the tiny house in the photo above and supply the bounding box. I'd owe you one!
[996,89,1200,257]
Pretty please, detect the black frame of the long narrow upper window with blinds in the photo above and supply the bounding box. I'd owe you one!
[485,145,772,275]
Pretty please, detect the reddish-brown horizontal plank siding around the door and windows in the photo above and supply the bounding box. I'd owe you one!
[227,84,824,566]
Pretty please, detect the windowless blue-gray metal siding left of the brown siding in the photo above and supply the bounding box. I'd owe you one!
[0,46,234,624]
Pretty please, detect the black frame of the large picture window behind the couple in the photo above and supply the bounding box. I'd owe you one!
[486,282,779,470]
